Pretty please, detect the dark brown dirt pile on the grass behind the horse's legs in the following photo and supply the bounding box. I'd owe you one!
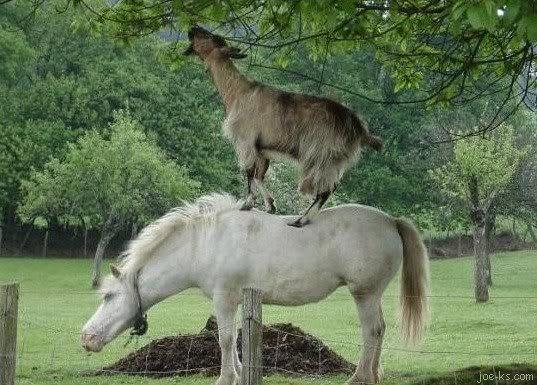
[99,317,355,377]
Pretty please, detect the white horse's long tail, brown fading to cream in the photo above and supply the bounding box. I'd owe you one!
[395,218,429,343]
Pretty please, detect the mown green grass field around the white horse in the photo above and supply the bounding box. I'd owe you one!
[0,252,537,385]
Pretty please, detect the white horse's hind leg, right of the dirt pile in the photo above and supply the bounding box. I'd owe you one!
[347,291,386,385]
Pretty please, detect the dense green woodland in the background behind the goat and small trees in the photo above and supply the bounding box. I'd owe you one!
[0,1,537,272]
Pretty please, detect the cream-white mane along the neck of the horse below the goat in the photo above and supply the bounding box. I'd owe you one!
[119,193,240,275]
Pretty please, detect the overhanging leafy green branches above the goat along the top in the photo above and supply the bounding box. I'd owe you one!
[9,0,537,130]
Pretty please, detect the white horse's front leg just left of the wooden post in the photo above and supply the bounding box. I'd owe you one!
[213,293,241,385]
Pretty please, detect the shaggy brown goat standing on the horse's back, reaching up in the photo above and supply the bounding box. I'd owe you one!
[185,26,382,227]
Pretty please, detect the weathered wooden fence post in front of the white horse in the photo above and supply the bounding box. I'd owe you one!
[242,288,263,385]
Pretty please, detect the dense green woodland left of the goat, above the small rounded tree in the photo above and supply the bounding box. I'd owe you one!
[0,3,240,230]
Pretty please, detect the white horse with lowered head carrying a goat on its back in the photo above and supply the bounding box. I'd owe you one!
[82,194,428,385]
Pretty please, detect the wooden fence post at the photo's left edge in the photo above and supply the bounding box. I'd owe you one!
[0,283,19,385]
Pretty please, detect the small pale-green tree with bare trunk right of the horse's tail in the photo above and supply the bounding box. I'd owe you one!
[430,125,527,302]
